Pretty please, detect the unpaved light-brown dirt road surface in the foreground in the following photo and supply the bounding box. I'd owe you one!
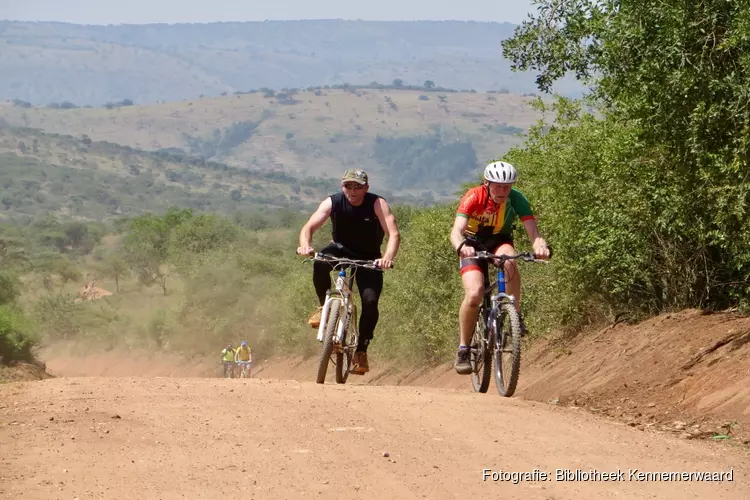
[0,377,750,500]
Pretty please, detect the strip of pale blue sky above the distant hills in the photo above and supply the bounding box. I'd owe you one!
[0,0,533,24]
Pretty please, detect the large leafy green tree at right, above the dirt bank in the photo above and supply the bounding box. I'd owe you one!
[503,0,750,312]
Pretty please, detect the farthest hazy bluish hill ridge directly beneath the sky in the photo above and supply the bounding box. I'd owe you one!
[0,20,580,106]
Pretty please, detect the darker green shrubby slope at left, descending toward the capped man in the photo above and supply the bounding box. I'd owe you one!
[0,127,344,220]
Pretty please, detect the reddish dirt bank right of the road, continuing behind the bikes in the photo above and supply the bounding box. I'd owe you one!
[259,310,750,444]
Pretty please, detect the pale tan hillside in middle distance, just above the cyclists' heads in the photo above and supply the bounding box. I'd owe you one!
[0,88,538,196]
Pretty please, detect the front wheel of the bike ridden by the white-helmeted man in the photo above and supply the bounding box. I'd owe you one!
[494,303,521,398]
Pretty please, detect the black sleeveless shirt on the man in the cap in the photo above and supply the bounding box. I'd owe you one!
[331,193,385,259]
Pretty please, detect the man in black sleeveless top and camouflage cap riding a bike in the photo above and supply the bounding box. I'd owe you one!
[297,169,401,374]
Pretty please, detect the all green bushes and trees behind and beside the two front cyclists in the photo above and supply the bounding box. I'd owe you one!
[0,0,750,363]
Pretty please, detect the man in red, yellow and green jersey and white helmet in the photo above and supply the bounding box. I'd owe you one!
[450,161,549,374]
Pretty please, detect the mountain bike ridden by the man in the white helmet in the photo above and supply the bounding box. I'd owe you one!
[458,240,552,398]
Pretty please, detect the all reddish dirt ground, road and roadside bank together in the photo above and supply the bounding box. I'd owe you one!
[0,311,750,500]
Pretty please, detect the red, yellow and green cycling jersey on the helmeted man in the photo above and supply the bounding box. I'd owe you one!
[456,186,534,240]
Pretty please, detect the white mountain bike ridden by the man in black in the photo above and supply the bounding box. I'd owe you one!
[305,253,382,384]
